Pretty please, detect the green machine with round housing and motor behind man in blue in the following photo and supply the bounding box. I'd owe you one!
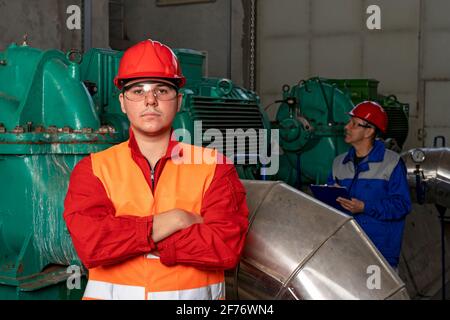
[272,77,408,189]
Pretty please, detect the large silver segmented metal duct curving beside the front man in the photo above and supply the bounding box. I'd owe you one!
[227,180,409,300]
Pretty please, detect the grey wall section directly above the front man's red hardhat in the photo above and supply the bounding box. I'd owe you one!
[124,0,249,85]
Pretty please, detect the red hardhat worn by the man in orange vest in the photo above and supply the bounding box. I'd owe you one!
[114,39,186,90]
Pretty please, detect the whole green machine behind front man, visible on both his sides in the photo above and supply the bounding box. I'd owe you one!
[0,44,270,299]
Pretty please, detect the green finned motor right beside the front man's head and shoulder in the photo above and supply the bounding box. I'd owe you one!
[174,49,271,180]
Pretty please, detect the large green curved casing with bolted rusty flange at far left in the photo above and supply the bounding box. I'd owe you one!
[0,44,122,299]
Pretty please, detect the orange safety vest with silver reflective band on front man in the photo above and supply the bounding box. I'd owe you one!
[84,142,225,300]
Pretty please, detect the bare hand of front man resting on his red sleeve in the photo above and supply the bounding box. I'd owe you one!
[152,209,203,242]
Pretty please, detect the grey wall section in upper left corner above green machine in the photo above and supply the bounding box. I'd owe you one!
[0,0,109,51]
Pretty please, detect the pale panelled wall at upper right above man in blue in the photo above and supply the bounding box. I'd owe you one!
[257,0,450,149]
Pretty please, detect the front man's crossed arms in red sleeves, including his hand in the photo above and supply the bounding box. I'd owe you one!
[64,157,248,269]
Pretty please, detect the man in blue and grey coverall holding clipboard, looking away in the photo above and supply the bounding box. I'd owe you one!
[328,101,411,271]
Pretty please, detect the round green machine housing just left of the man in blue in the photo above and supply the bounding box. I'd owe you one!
[273,78,353,188]
